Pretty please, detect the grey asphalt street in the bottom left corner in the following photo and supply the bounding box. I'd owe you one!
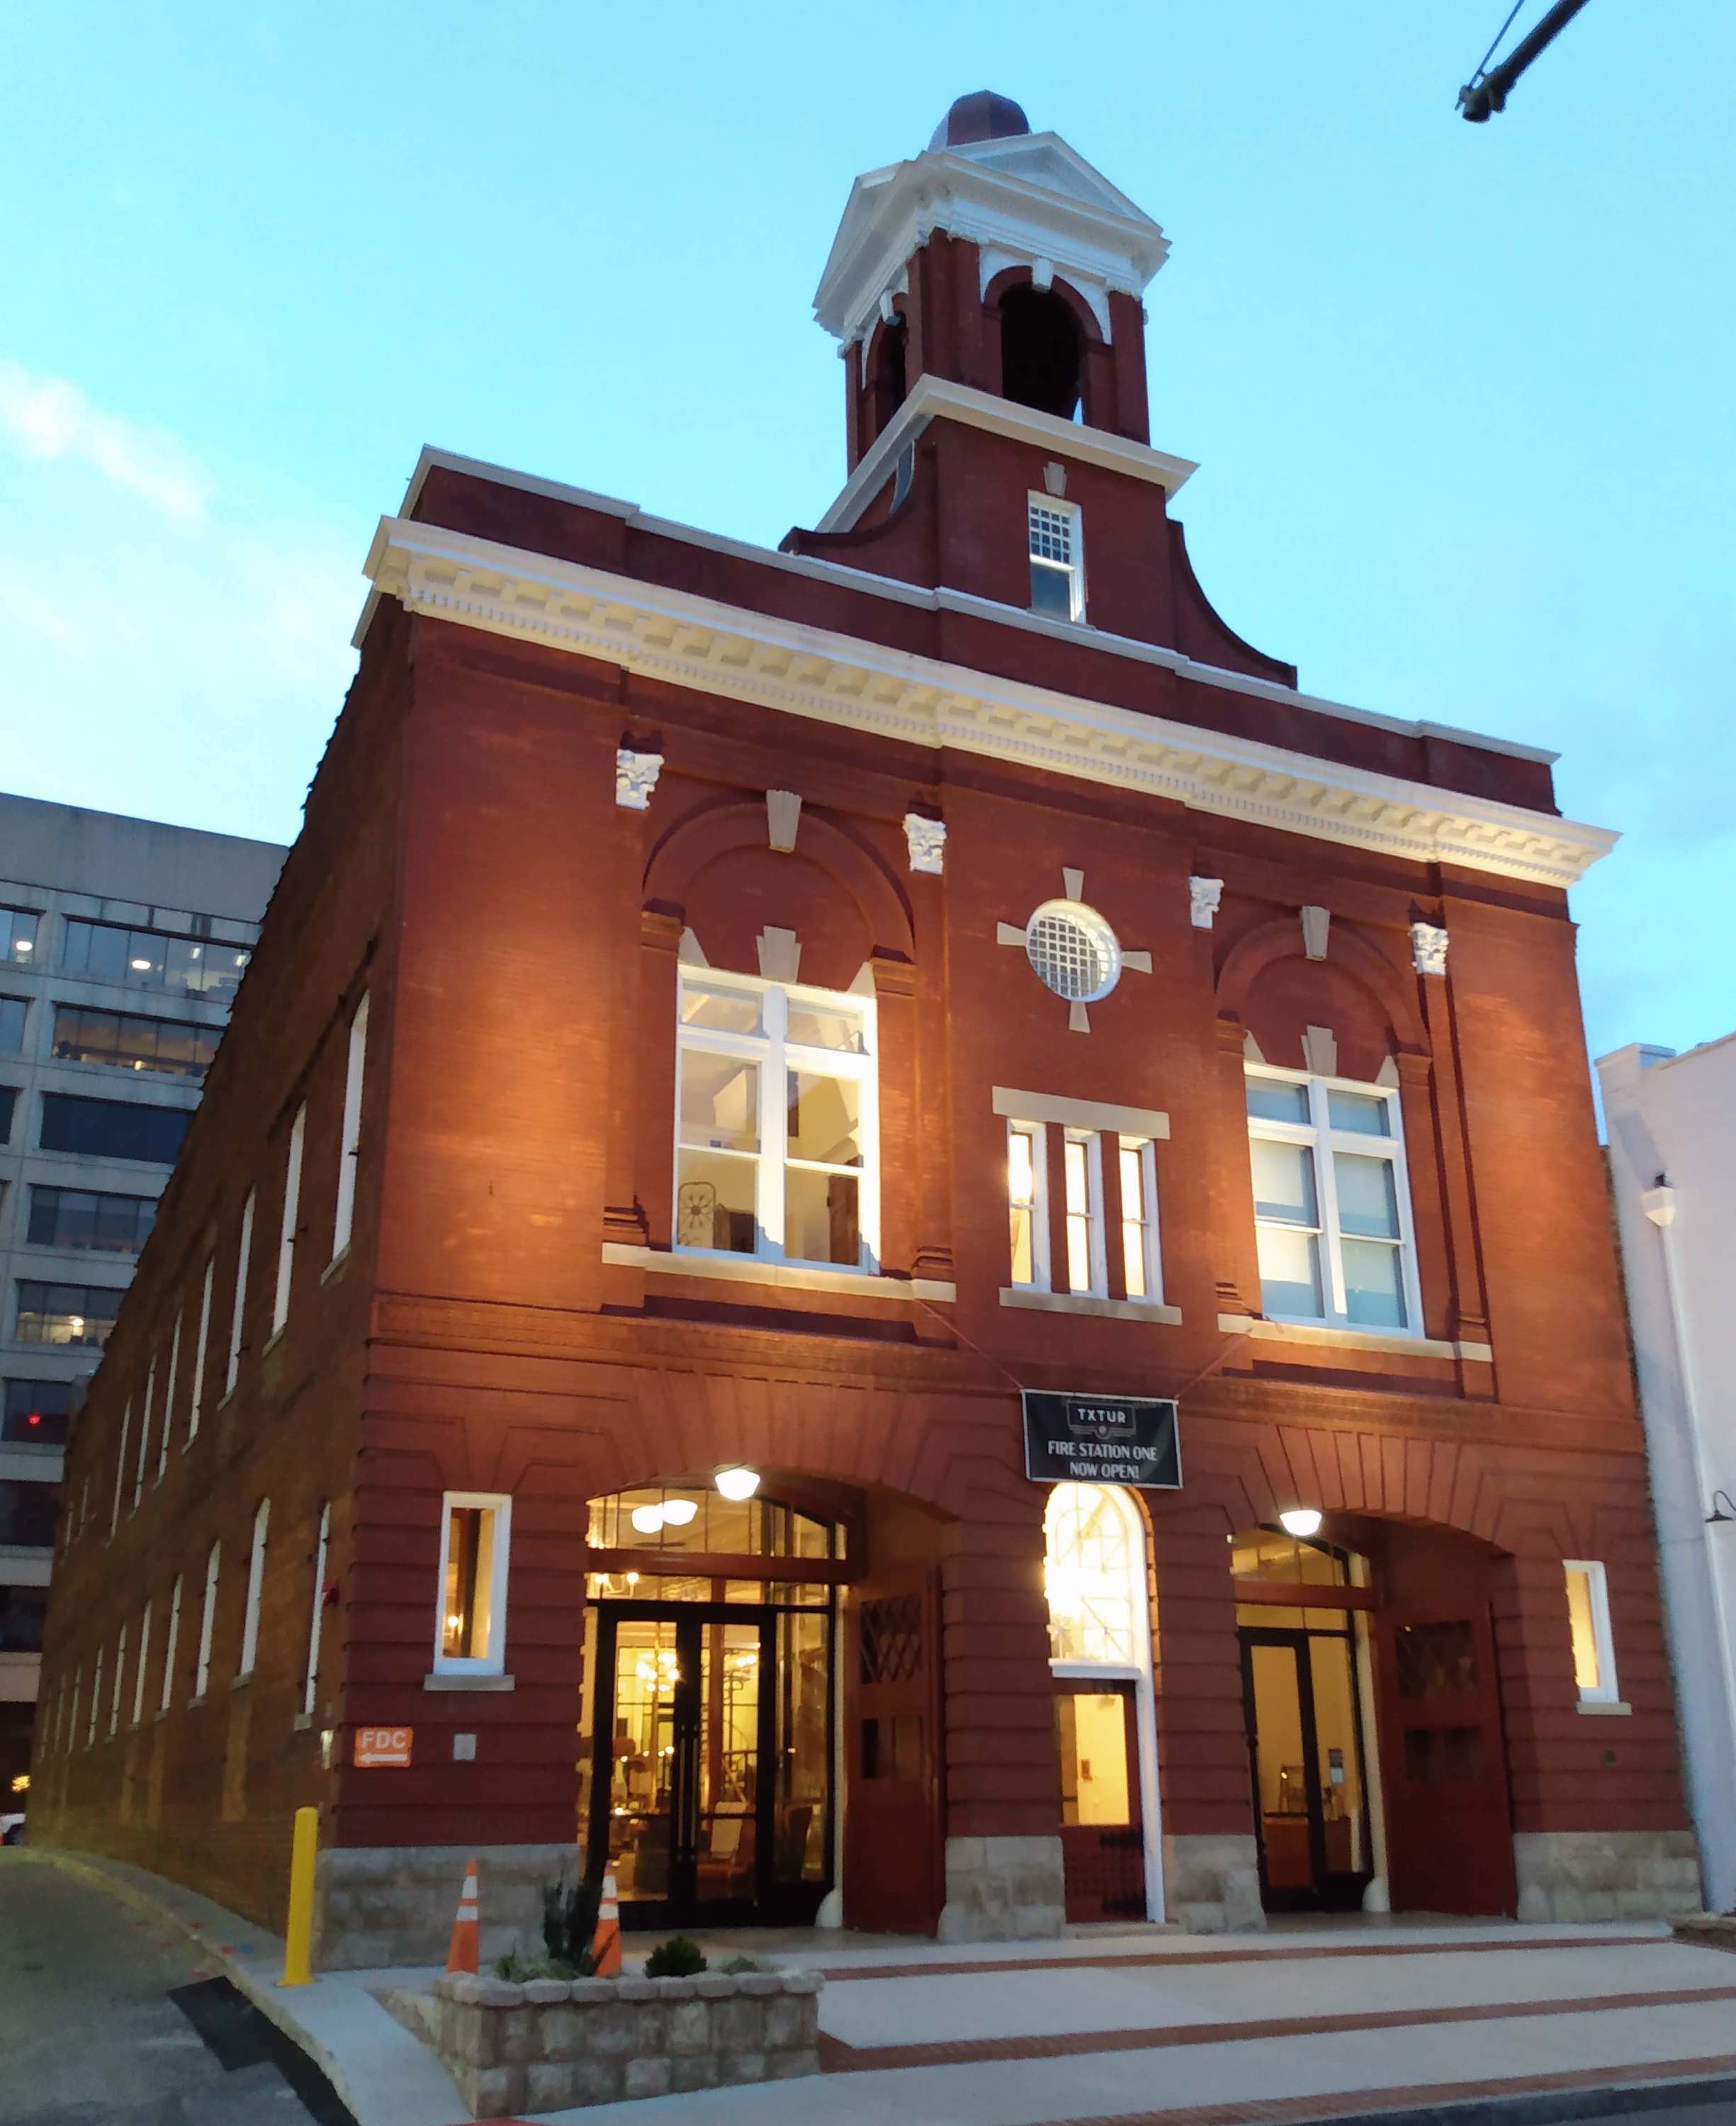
[0,1852,346,2126]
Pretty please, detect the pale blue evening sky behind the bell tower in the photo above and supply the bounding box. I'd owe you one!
[0,0,1736,1052]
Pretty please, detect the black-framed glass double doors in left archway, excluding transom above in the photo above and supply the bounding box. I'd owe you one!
[591,1601,831,1928]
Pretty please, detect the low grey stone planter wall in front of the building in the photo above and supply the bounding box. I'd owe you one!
[425,1971,825,2117]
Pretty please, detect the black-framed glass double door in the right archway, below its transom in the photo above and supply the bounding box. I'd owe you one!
[1241,1618,1373,1911]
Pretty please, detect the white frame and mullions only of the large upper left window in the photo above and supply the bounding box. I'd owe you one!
[672,967,879,1276]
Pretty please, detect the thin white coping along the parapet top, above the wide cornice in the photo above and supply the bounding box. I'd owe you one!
[388,444,1560,767]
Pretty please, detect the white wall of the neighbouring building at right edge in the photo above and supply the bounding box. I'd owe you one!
[1598,1035,1736,1911]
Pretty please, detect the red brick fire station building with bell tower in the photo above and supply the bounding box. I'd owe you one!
[32,96,1696,1962]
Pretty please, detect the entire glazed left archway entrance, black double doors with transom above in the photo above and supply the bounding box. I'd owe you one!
[578,1484,848,1928]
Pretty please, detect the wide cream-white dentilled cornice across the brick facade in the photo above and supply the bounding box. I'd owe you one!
[366,517,1617,887]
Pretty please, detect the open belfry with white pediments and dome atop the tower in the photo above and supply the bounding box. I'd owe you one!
[814,89,1168,472]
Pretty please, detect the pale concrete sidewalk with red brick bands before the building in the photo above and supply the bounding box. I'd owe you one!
[21,1847,1736,2126]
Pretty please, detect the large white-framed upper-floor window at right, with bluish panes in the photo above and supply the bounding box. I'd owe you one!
[1247,1067,1421,1335]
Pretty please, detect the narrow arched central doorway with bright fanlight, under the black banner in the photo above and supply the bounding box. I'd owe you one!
[1043,1484,1162,1924]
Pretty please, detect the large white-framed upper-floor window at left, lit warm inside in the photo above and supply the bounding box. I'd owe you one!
[676,969,879,1269]
